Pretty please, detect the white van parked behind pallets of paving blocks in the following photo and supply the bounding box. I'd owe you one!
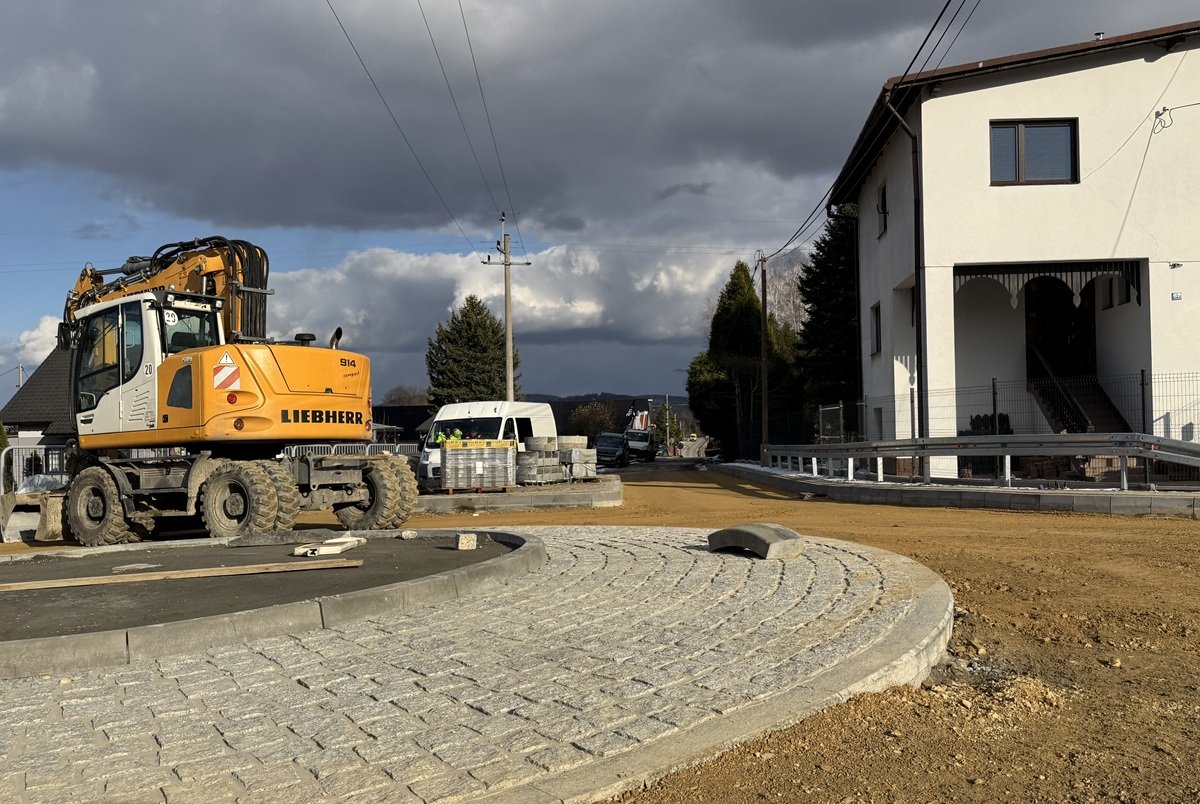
[416,401,558,488]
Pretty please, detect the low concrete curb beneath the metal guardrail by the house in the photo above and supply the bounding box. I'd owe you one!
[712,463,1200,520]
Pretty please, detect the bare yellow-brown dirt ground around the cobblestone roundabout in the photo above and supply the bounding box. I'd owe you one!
[409,469,1200,804]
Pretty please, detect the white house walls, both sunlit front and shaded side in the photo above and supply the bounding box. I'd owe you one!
[859,40,1200,460]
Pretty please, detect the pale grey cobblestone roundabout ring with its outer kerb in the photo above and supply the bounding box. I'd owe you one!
[0,527,949,804]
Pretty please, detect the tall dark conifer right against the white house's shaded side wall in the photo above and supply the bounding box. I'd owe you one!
[798,205,862,415]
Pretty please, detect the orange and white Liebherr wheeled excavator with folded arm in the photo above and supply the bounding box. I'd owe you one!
[58,236,418,545]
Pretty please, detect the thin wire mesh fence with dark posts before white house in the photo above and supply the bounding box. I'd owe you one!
[844,372,1200,442]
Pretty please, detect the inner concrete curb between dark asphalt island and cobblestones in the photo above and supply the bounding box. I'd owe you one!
[0,532,548,678]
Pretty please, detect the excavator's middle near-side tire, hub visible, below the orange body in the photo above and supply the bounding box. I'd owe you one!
[199,458,278,539]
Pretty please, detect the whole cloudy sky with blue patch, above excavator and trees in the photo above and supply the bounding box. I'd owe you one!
[0,0,1198,403]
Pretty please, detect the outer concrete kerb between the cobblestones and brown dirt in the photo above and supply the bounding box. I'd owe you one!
[478,536,954,804]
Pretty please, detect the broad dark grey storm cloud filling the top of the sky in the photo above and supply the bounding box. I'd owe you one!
[0,0,1189,246]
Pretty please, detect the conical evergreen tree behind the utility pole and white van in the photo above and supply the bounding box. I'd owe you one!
[425,295,522,407]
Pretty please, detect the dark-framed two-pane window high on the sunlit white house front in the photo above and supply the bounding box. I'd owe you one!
[991,120,1079,185]
